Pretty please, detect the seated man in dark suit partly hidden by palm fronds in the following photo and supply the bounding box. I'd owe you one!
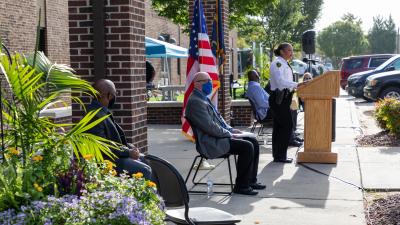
[88,79,151,179]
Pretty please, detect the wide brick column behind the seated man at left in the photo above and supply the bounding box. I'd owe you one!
[68,0,147,152]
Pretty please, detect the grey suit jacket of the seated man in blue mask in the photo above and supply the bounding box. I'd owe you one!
[185,89,232,159]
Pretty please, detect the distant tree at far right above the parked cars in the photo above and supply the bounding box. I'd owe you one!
[368,16,396,54]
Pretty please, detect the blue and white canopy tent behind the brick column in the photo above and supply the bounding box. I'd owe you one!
[145,37,188,58]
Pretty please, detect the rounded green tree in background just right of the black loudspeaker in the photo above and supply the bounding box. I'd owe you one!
[317,14,368,65]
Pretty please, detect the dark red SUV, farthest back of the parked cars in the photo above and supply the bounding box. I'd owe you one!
[340,54,394,89]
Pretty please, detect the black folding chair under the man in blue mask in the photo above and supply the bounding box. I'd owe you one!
[185,118,237,195]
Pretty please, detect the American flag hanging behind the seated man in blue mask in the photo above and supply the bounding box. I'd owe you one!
[181,0,220,140]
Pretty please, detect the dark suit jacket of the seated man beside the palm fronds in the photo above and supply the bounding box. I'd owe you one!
[87,100,129,158]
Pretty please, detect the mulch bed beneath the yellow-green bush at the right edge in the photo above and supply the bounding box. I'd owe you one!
[356,131,400,147]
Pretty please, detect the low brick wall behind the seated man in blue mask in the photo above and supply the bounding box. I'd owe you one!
[147,100,253,126]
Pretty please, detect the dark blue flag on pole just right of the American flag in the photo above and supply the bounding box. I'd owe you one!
[211,0,226,73]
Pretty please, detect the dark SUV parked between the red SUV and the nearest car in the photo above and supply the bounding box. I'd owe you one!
[346,55,400,100]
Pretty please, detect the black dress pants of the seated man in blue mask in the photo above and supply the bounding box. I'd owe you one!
[229,138,260,188]
